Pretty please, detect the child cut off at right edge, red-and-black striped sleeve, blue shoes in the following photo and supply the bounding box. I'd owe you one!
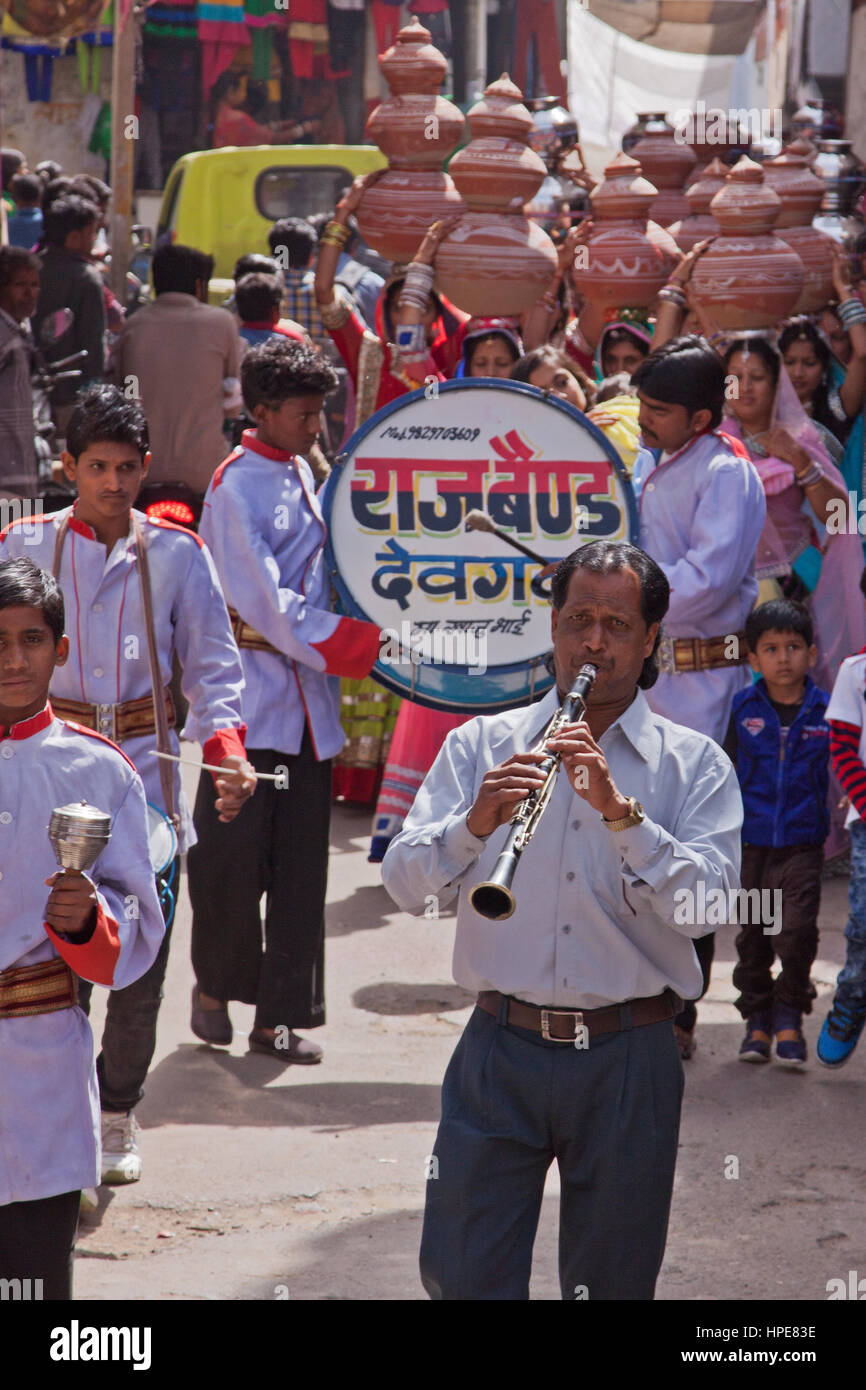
[816,570,866,1068]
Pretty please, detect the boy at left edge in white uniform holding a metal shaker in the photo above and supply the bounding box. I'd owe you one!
[0,560,164,1298]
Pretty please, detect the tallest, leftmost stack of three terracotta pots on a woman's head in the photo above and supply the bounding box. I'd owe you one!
[357,21,463,261]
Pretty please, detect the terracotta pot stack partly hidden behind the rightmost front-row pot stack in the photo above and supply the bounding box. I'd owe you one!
[762,142,833,314]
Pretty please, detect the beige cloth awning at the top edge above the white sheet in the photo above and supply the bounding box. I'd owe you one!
[582,0,765,56]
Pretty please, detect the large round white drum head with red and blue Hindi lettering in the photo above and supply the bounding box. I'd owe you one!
[322,379,637,714]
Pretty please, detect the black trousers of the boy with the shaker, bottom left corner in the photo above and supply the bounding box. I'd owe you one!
[0,1189,81,1295]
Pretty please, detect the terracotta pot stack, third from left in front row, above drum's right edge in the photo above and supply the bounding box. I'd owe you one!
[574,154,678,309]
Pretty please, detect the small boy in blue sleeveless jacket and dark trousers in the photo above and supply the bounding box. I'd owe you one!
[724,599,830,1069]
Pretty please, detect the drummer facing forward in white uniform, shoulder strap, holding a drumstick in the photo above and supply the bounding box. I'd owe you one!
[0,386,256,1183]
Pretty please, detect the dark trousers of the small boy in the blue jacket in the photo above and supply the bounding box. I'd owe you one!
[734,845,824,1019]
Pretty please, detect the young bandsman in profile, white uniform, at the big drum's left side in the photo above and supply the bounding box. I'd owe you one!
[189,339,381,1065]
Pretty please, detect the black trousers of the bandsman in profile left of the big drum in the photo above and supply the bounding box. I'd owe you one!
[188,728,331,1029]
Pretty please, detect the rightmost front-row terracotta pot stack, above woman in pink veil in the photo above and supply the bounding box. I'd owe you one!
[691,157,805,329]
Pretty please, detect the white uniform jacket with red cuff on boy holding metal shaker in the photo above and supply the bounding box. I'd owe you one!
[0,705,164,1205]
